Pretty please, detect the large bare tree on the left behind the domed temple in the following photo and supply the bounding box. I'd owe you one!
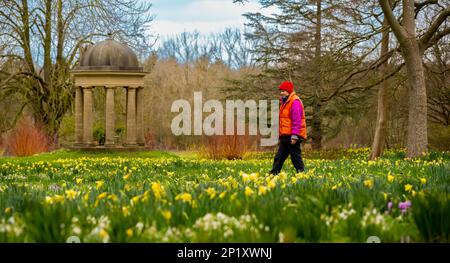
[0,0,152,142]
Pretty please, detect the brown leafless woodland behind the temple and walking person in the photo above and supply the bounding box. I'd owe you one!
[0,0,450,158]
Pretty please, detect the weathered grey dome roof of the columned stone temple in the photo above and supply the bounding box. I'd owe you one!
[76,38,142,71]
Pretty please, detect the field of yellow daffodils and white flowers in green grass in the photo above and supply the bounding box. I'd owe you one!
[0,149,450,242]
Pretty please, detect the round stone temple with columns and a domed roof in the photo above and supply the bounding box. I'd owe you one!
[71,38,146,148]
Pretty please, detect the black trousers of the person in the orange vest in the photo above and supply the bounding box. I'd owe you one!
[270,136,305,174]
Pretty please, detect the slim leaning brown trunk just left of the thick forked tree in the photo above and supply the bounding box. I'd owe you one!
[369,18,389,160]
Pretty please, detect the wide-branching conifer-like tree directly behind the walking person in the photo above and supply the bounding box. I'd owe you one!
[235,0,401,149]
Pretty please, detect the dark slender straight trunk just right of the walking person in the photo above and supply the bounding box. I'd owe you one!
[311,0,322,149]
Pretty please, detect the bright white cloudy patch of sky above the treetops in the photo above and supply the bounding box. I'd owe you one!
[151,0,270,38]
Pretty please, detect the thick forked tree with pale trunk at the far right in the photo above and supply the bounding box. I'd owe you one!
[379,0,450,158]
